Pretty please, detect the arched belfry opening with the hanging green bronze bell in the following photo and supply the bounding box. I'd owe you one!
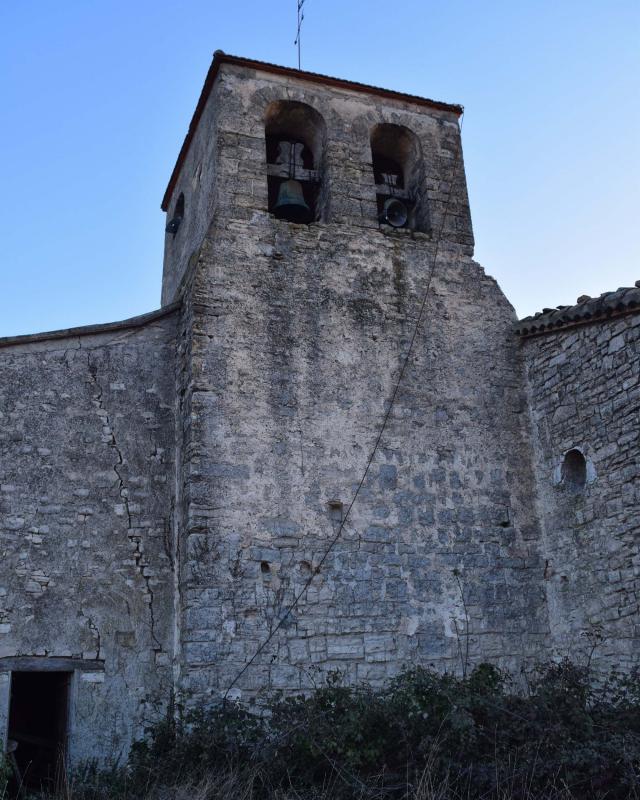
[264,100,327,223]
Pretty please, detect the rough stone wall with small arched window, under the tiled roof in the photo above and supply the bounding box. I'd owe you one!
[522,311,640,668]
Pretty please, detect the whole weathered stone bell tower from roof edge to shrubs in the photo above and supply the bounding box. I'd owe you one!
[163,52,545,699]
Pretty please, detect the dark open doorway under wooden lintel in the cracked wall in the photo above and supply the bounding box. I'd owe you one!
[8,672,72,791]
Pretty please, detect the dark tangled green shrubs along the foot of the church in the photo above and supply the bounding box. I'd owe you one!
[72,661,640,800]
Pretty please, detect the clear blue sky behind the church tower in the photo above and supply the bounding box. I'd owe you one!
[0,0,640,336]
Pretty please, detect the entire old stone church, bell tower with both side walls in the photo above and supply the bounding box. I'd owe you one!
[0,51,640,774]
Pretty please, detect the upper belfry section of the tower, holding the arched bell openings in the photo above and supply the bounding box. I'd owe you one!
[162,51,473,304]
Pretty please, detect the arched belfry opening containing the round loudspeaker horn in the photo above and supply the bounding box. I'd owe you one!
[371,123,431,233]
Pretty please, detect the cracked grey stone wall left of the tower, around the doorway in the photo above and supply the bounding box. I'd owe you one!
[0,314,175,761]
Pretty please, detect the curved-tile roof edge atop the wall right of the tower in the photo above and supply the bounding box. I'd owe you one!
[516,281,640,336]
